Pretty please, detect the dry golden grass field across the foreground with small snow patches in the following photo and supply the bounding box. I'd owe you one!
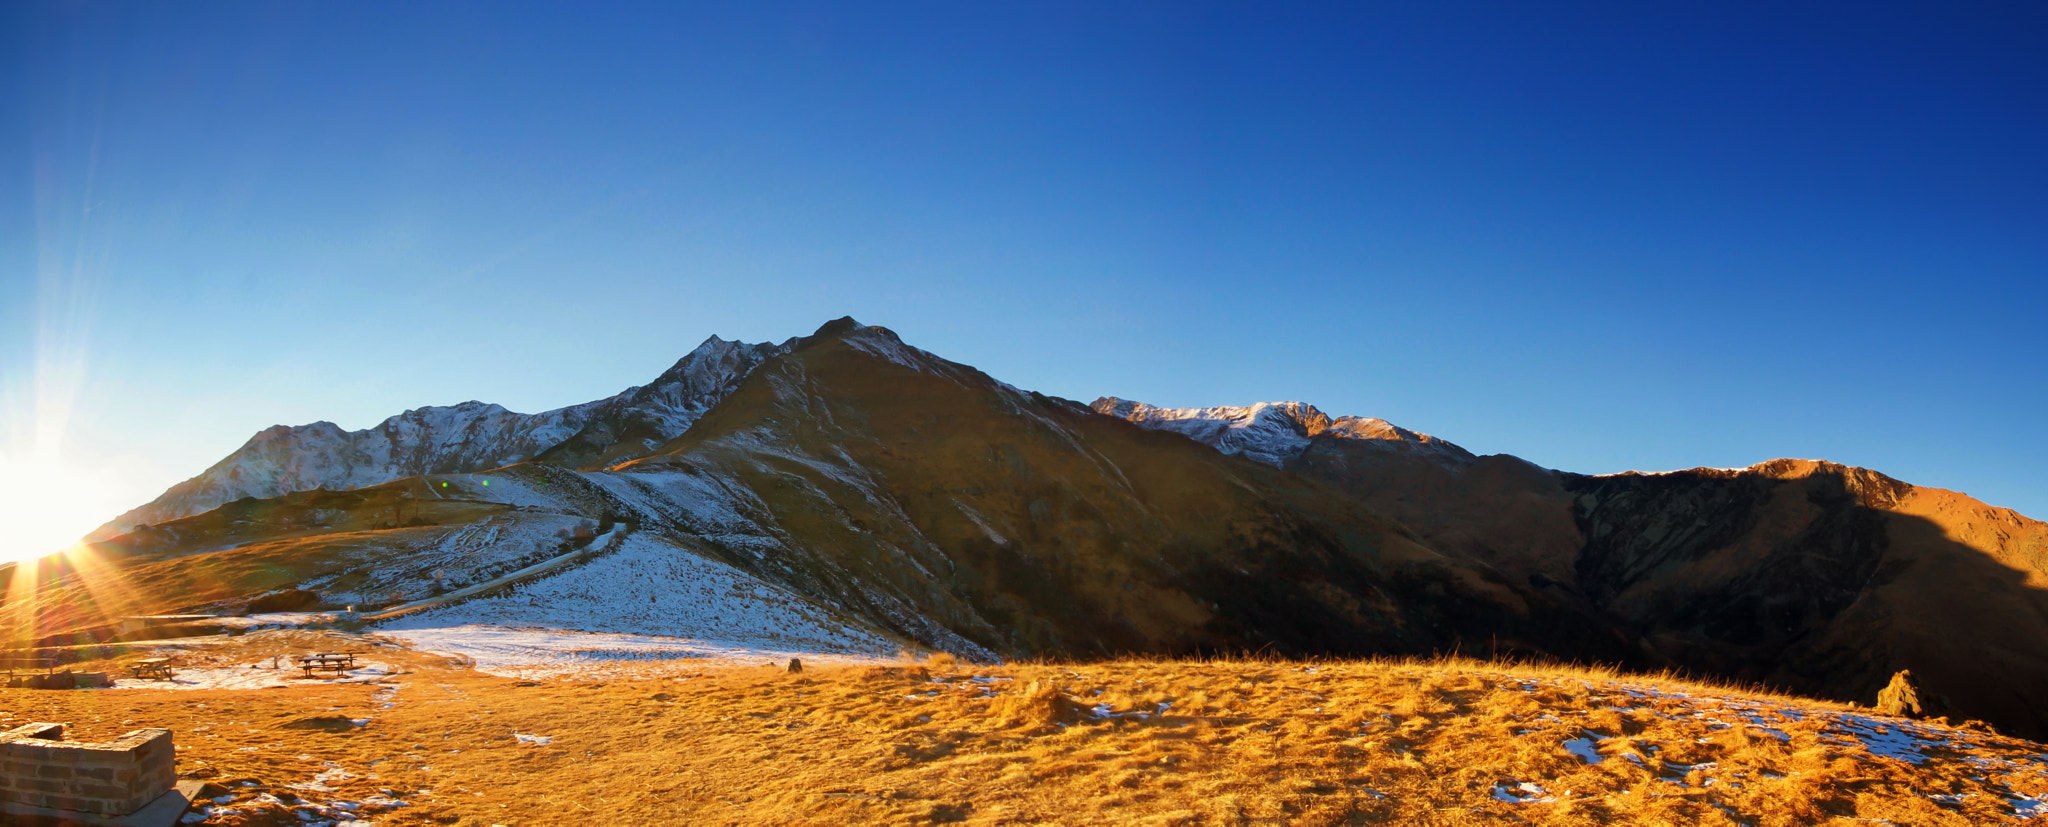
[0,639,2048,825]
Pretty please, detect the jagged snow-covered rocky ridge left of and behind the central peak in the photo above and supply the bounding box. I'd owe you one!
[90,336,791,538]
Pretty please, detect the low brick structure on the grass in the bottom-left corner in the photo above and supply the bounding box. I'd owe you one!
[0,723,178,817]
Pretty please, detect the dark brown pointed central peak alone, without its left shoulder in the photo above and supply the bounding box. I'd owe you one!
[593,319,1626,657]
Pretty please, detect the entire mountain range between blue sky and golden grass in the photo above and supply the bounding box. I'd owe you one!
[24,319,2048,737]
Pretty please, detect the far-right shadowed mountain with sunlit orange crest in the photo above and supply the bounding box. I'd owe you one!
[1565,461,2048,739]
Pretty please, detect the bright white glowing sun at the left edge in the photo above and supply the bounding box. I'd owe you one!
[0,448,123,563]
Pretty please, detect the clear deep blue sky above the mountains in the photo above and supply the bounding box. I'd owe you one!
[0,2,2048,557]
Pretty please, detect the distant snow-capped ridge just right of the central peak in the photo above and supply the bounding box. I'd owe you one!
[1090,397,1473,469]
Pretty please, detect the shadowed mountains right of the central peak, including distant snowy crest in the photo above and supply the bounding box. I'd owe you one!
[1094,399,2048,737]
